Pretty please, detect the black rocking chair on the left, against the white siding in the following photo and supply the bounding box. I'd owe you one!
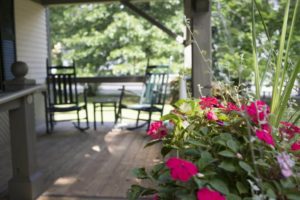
[46,62,89,133]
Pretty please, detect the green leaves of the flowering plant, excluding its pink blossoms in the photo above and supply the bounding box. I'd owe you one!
[128,83,300,200]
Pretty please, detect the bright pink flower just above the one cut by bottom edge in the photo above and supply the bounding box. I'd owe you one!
[166,157,198,182]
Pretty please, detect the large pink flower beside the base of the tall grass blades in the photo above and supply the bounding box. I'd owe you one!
[245,101,270,124]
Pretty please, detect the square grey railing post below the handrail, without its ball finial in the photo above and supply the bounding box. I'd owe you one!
[8,94,42,200]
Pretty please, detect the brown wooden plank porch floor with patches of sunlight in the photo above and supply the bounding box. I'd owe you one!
[1,124,160,200]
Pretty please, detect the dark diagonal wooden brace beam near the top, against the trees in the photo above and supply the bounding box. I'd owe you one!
[121,0,178,39]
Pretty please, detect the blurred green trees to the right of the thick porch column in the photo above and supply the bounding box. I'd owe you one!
[212,0,300,84]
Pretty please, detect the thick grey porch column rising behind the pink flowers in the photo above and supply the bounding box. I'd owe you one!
[185,0,212,97]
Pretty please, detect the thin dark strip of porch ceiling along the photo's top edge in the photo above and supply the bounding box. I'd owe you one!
[38,0,157,5]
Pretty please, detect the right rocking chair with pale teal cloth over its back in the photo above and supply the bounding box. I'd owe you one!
[117,65,169,130]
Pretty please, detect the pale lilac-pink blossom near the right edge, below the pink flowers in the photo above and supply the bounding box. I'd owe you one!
[277,152,295,178]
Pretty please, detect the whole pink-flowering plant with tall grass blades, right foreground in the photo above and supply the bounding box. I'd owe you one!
[128,0,300,200]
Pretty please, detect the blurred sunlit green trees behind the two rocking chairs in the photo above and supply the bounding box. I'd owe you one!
[50,0,183,75]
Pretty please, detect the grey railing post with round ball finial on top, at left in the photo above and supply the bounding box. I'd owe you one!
[5,61,42,200]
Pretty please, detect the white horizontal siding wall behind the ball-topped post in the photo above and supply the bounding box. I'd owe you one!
[15,0,47,133]
